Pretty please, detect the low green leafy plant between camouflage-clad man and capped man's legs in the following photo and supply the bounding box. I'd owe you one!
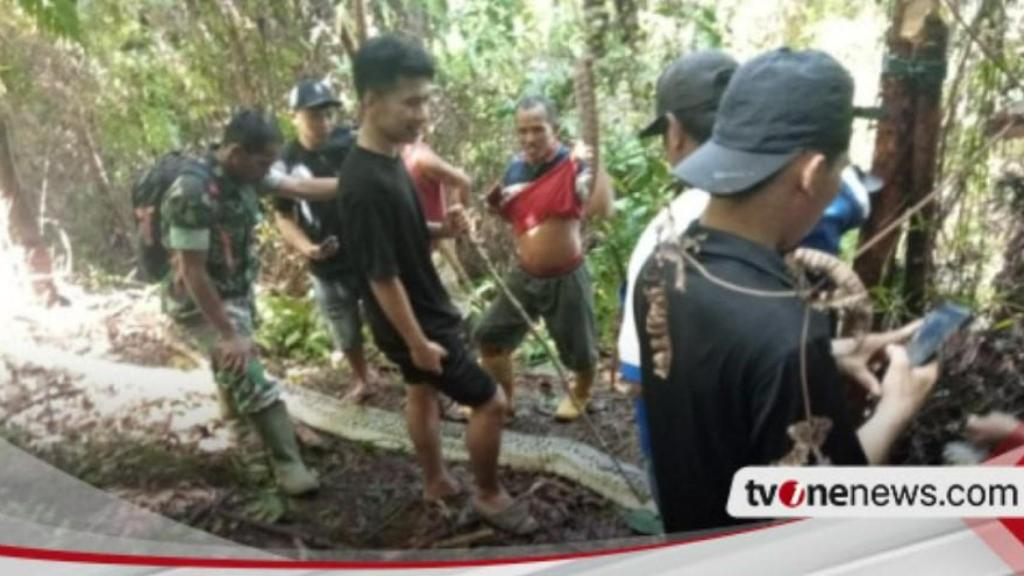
[256,294,333,362]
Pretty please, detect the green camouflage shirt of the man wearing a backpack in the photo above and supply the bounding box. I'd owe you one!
[160,156,262,320]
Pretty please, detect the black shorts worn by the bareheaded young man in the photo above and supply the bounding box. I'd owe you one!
[384,334,498,408]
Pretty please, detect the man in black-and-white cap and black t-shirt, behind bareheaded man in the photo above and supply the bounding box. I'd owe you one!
[273,80,373,402]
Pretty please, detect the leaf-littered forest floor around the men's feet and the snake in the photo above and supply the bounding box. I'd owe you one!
[0,282,640,557]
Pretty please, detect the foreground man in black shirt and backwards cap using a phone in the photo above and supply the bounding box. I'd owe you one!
[634,49,937,532]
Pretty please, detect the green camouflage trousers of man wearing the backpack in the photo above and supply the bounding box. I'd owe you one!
[174,298,281,416]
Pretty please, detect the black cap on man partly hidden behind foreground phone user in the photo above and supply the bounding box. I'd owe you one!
[640,50,739,138]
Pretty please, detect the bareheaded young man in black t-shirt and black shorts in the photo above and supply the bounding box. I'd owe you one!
[340,36,537,533]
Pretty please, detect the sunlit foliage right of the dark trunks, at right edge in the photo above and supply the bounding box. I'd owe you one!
[917,0,1024,308]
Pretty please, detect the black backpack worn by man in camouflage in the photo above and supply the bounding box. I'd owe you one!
[131,151,213,283]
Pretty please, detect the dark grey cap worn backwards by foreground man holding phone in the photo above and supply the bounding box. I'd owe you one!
[673,48,854,196]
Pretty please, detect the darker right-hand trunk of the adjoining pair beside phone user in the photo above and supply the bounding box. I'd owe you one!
[903,14,949,316]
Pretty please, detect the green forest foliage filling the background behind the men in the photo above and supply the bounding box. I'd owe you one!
[0,0,1024,348]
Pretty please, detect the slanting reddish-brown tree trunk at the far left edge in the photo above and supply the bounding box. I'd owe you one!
[0,117,67,306]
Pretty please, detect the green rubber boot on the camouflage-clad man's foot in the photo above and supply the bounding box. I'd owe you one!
[249,401,319,496]
